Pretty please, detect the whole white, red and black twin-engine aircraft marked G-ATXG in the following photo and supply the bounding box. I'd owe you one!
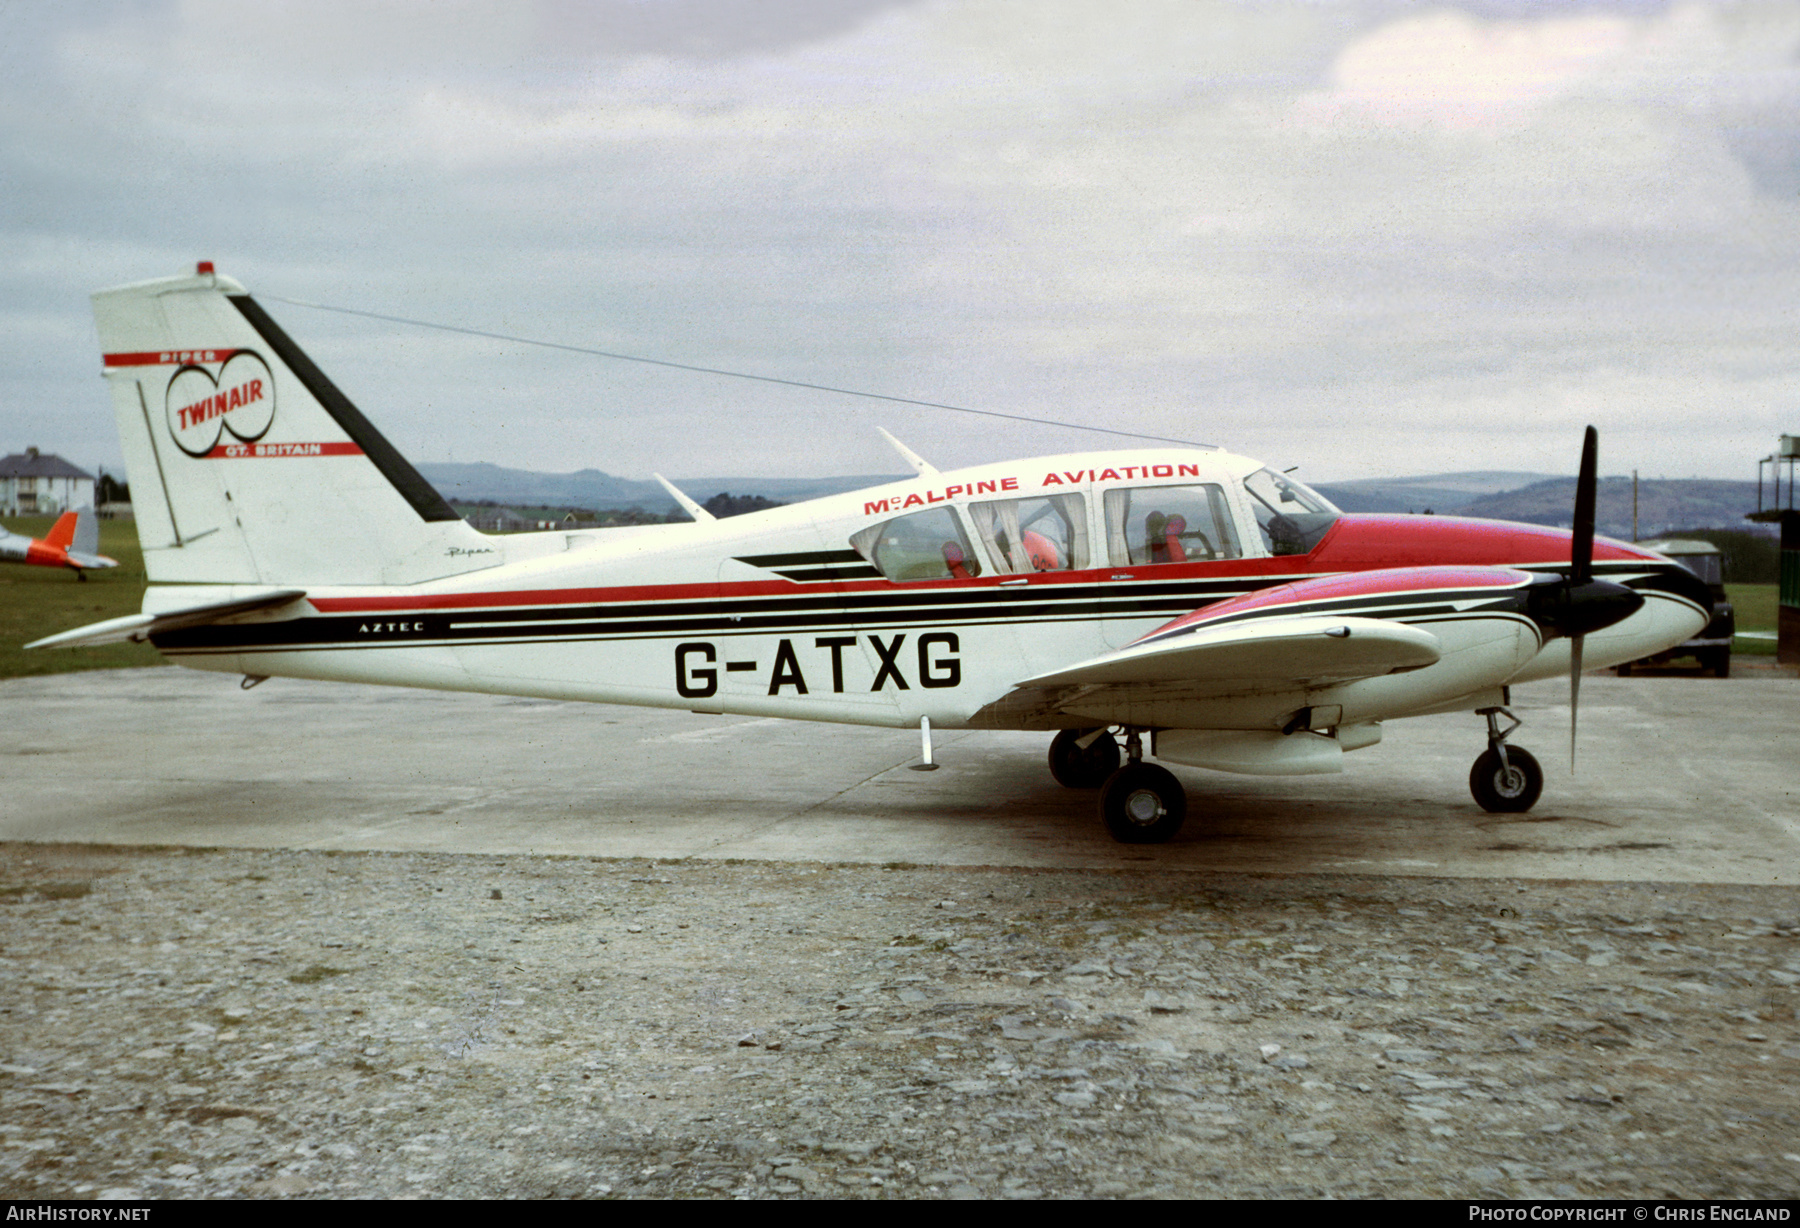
[29,265,1712,843]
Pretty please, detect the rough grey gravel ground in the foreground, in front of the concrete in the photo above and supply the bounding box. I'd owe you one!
[0,844,1800,1197]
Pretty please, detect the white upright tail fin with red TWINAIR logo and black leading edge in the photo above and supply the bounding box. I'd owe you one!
[94,263,500,585]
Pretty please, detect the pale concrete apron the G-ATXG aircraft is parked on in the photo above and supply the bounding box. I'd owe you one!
[0,668,1800,886]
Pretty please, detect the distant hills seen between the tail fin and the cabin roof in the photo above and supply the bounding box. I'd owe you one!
[418,463,904,511]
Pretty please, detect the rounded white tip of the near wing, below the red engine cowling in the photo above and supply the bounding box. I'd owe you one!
[1019,614,1444,686]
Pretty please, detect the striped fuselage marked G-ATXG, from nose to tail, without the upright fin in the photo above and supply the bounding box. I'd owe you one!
[144,450,1706,729]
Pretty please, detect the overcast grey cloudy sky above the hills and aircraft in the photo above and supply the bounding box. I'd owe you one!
[0,0,1800,493]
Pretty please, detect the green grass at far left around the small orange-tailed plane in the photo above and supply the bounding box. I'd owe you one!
[0,517,162,679]
